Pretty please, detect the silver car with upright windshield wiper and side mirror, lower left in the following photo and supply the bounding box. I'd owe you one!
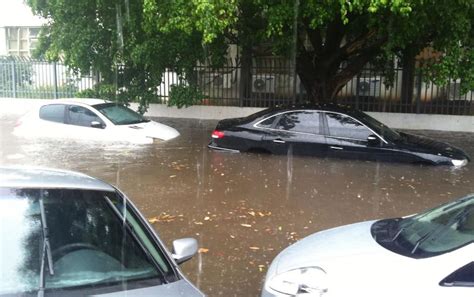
[0,167,204,297]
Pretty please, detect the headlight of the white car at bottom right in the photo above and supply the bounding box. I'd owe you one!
[268,267,328,296]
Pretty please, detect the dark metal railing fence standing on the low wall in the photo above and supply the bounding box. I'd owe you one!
[0,57,474,115]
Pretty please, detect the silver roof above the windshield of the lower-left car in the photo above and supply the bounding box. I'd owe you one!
[0,166,115,191]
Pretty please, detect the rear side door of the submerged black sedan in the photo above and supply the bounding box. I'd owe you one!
[264,110,326,156]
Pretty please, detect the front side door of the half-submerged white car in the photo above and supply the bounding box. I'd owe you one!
[66,105,108,140]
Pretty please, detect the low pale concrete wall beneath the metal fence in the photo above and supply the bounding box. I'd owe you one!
[0,98,474,133]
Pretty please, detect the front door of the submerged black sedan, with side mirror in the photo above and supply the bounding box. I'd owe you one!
[324,112,382,160]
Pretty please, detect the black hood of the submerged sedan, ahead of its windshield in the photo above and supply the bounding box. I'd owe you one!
[397,132,470,160]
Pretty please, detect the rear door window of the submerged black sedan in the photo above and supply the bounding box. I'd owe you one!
[275,111,319,134]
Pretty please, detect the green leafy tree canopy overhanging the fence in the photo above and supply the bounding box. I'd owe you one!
[28,0,474,103]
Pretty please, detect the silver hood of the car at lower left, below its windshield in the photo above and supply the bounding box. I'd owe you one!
[89,280,204,297]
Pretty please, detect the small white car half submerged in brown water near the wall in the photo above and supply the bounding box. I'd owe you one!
[13,99,179,144]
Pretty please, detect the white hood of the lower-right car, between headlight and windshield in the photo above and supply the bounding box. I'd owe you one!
[273,221,399,274]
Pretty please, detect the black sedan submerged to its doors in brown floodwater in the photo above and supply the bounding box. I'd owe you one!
[209,104,469,166]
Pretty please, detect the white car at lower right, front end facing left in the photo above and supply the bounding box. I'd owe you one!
[262,194,474,297]
